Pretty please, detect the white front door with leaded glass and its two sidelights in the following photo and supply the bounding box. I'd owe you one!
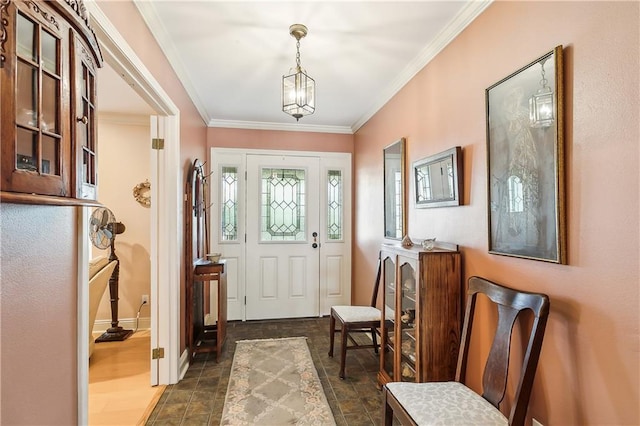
[210,148,351,320]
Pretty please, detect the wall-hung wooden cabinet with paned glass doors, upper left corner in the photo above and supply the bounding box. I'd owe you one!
[0,0,102,202]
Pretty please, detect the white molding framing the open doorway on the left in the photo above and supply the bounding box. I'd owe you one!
[76,1,183,424]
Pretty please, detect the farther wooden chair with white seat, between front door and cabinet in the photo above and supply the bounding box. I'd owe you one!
[329,255,382,379]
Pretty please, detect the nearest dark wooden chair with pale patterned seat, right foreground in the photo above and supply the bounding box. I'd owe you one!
[383,277,549,426]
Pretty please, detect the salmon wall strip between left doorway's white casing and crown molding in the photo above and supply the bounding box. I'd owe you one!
[97,0,207,352]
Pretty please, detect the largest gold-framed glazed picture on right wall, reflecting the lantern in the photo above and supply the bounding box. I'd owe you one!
[485,46,567,264]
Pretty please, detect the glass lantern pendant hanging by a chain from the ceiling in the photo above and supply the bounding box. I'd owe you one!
[282,24,316,121]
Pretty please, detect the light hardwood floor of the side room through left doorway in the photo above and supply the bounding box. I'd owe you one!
[89,330,165,426]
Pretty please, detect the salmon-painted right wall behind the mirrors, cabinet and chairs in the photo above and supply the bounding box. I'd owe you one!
[354,2,640,425]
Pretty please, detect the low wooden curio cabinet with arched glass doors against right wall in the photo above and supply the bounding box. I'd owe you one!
[378,244,462,385]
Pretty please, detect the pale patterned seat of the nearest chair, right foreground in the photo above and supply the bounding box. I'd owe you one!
[386,382,509,426]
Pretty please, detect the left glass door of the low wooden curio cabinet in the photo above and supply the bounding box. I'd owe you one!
[382,253,396,380]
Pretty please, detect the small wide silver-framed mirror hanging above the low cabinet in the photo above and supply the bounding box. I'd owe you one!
[413,146,462,208]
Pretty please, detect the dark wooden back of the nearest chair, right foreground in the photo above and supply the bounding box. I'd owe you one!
[456,277,549,425]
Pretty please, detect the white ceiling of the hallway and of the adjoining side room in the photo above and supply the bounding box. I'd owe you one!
[99,0,491,133]
